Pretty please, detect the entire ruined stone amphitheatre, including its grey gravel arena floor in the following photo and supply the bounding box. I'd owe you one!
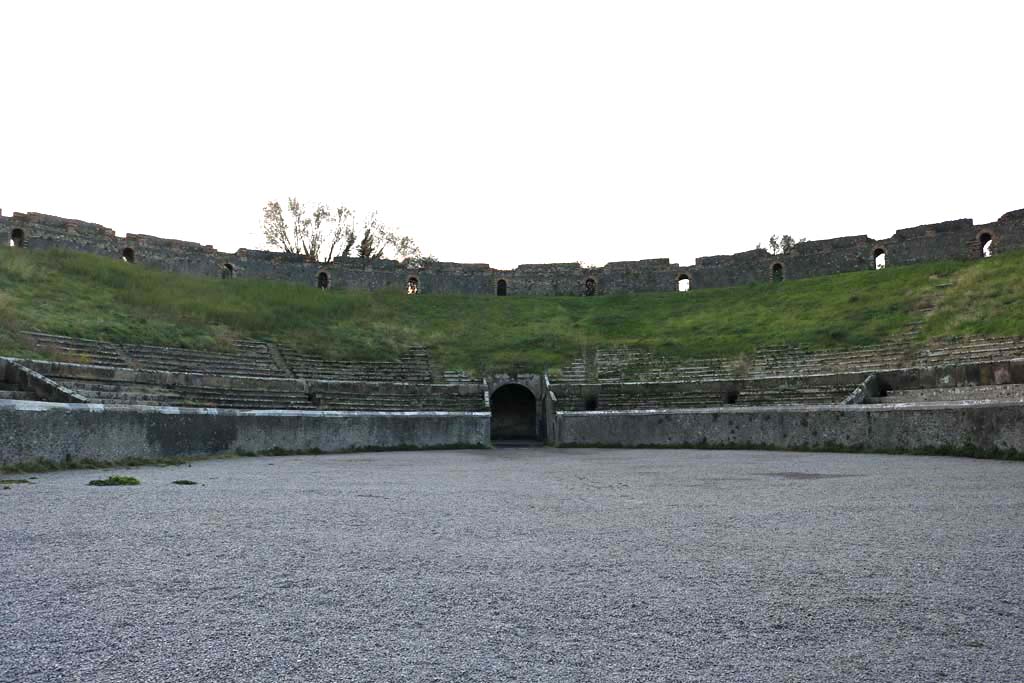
[0,201,1024,683]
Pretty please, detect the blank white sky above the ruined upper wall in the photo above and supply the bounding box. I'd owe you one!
[0,0,1024,267]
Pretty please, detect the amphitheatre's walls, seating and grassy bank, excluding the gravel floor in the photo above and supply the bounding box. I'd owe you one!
[0,204,1024,466]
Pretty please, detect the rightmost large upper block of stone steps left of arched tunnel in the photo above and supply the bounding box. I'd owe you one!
[281,346,432,384]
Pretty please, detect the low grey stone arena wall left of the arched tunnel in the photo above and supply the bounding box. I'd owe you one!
[0,400,490,466]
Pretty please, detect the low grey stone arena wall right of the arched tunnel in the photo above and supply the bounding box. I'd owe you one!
[549,401,1024,455]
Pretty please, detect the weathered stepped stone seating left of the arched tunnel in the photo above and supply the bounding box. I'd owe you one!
[14,333,486,412]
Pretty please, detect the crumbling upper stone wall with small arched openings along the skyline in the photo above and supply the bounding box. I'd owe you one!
[0,209,1024,296]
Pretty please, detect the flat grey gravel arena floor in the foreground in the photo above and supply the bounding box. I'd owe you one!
[0,447,1024,683]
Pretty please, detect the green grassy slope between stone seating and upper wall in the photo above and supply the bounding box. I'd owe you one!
[0,249,1024,371]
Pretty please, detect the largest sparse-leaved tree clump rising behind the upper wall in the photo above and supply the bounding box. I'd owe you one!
[263,198,437,267]
